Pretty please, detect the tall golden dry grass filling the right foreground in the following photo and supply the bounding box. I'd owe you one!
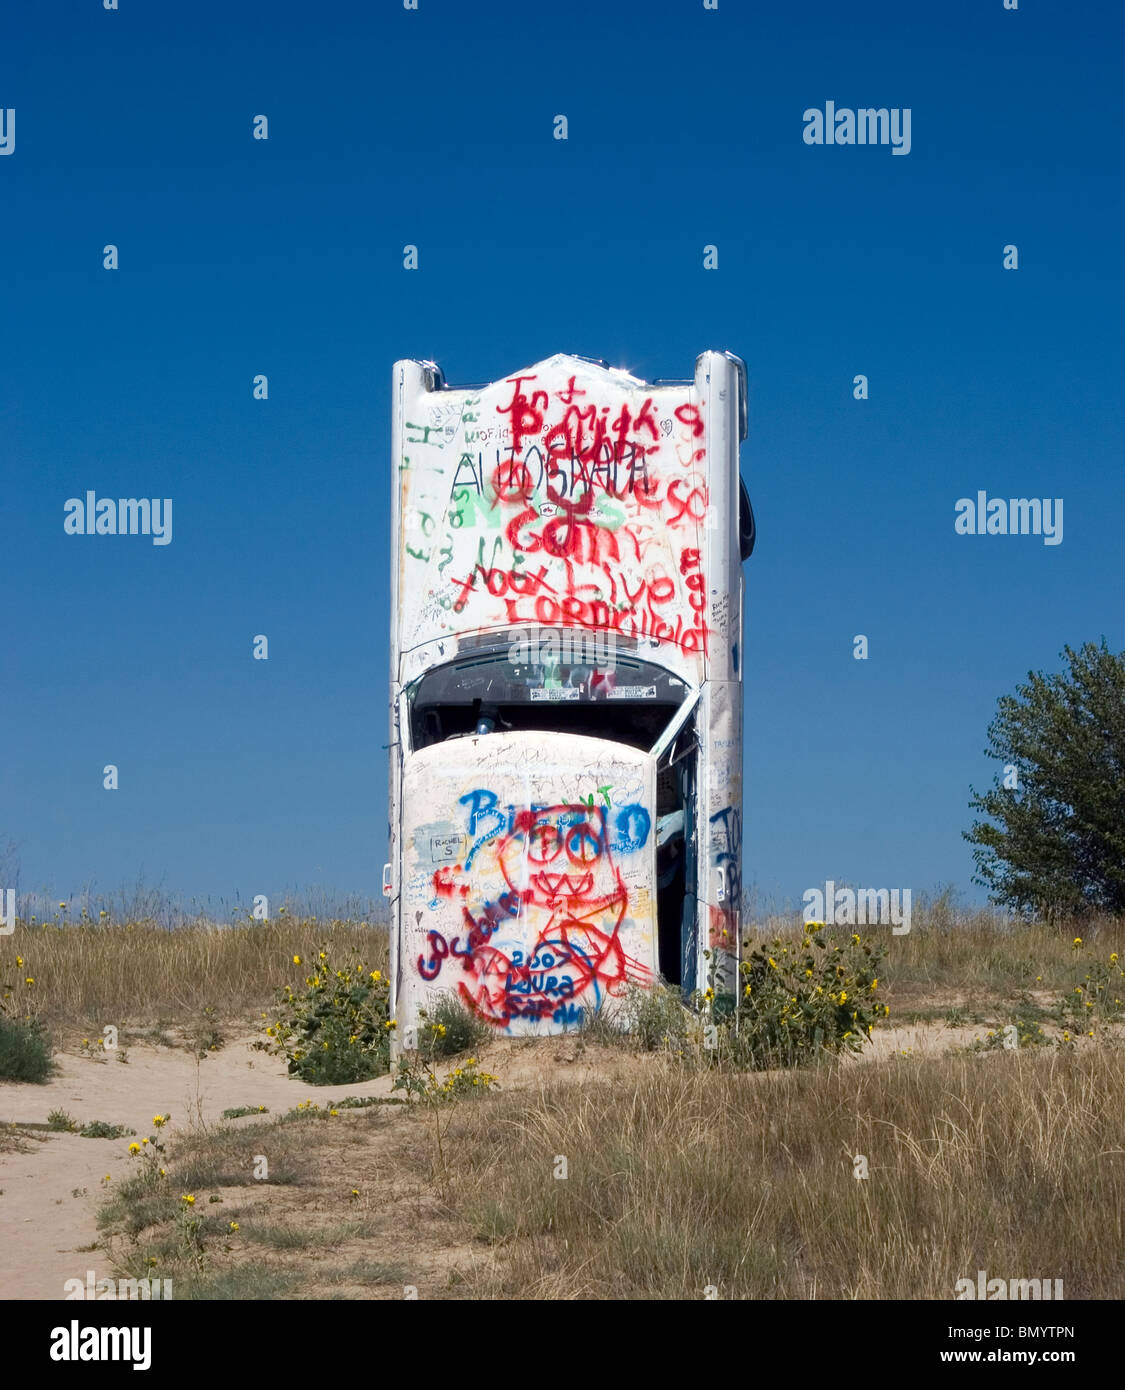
[446,1048,1125,1300]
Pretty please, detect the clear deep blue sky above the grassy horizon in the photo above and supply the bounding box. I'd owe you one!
[0,0,1125,901]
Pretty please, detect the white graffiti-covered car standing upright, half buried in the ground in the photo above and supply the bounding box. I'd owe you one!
[384,352,754,1047]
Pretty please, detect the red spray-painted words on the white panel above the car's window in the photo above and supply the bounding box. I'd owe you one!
[445,373,709,655]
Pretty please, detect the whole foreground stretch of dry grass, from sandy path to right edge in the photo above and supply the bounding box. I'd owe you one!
[98,1044,1125,1300]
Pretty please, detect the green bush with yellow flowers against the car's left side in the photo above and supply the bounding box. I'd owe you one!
[254,942,395,1086]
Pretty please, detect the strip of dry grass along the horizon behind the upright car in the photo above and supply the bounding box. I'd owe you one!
[0,898,1125,1031]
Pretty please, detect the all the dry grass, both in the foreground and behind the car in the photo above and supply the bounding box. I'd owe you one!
[0,901,1125,1300]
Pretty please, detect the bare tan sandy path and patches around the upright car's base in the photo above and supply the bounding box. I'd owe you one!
[0,1023,982,1298]
